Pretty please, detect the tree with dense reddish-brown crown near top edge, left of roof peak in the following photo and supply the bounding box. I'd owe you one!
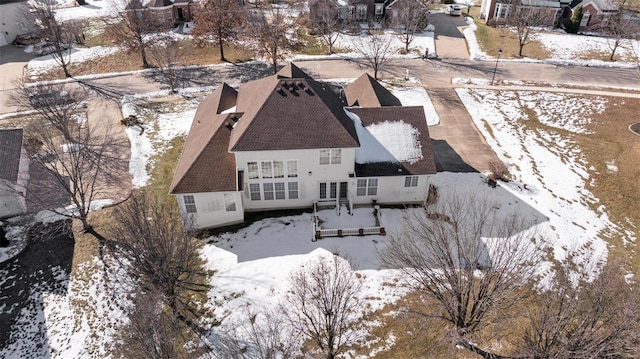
[193,0,246,61]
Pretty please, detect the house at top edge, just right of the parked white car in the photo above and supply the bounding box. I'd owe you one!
[480,0,569,26]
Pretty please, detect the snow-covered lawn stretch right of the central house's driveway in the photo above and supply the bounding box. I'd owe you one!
[457,88,633,257]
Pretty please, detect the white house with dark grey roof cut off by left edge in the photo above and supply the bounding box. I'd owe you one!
[0,129,29,219]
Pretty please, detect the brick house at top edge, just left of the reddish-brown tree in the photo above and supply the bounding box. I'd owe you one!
[127,0,197,25]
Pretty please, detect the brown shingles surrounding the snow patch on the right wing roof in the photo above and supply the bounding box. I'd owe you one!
[349,106,436,177]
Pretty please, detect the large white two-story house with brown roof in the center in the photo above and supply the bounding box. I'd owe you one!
[170,64,436,228]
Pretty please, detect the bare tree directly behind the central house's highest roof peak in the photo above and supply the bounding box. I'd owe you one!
[246,8,297,74]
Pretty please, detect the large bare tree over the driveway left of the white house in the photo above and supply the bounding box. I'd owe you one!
[12,84,128,239]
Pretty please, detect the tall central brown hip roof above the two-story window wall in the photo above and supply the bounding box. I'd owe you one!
[229,64,359,152]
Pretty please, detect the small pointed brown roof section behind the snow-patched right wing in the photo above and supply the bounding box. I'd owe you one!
[344,73,402,107]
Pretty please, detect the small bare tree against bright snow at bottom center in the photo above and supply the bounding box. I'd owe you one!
[283,255,362,359]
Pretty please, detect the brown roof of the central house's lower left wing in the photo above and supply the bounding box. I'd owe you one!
[169,89,237,194]
